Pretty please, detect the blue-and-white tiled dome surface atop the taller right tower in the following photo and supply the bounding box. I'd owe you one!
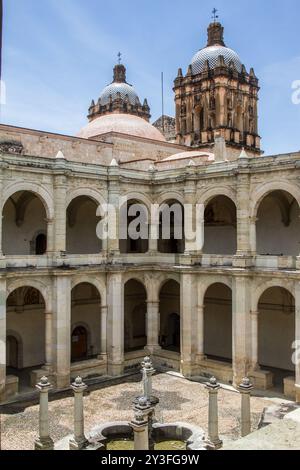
[191,45,242,75]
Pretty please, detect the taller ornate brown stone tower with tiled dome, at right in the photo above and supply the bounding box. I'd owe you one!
[174,22,261,154]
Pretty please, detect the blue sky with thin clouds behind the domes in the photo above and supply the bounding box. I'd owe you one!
[2,0,300,154]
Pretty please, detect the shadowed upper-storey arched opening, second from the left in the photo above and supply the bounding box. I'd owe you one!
[66,196,102,255]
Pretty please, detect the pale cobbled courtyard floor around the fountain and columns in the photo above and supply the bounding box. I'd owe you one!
[1,374,278,450]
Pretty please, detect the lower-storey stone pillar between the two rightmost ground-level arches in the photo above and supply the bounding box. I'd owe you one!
[232,276,251,386]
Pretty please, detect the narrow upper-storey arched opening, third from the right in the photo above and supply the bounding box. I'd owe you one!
[158,200,185,254]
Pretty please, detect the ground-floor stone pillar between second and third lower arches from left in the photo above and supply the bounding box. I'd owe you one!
[107,273,124,376]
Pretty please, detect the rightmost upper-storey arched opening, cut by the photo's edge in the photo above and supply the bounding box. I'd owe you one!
[256,191,300,256]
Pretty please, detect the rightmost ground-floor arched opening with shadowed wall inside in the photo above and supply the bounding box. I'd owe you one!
[258,287,295,388]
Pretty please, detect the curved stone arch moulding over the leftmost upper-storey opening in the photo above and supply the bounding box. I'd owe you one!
[1,181,54,220]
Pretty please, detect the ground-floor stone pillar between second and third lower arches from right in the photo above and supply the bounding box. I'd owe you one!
[180,274,198,377]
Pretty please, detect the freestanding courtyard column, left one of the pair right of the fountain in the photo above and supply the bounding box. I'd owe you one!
[206,377,223,450]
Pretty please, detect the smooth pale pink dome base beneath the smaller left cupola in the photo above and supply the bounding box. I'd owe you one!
[78,113,166,142]
